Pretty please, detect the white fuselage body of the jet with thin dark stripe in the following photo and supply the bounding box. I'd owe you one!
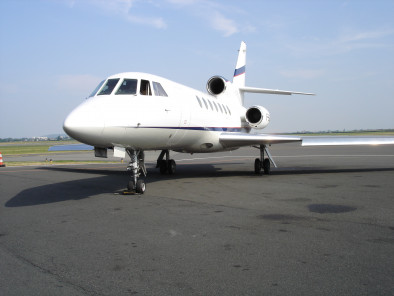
[64,73,248,153]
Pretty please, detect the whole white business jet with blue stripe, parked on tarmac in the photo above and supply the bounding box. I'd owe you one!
[63,42,394,193]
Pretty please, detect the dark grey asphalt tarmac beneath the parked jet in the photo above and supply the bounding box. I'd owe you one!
[0,144,394,295]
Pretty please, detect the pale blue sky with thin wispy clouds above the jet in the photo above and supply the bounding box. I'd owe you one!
[0,0,394,138]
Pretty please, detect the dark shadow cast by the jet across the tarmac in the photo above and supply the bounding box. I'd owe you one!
[5,163,394,207]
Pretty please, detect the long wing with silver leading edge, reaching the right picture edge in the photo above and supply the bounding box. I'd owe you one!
[219,133,394,148]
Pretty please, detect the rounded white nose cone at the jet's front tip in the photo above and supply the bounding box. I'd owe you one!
[63,105,104,145]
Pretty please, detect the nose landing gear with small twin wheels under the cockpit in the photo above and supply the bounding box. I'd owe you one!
[126,149,147,194]
